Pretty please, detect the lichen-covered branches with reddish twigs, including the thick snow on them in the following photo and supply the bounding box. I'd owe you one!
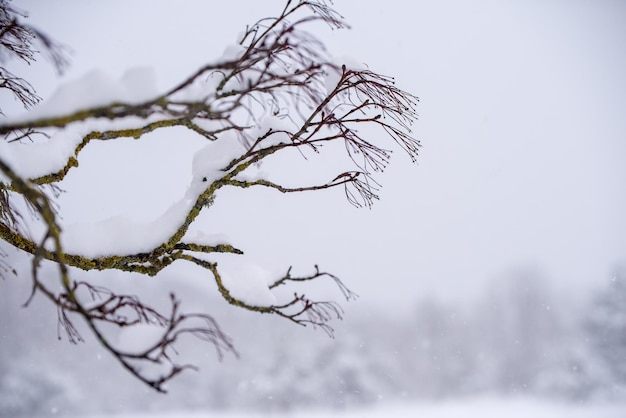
[0,0,419,391]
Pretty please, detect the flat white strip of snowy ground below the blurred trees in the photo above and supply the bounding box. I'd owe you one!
[79,399,626,418]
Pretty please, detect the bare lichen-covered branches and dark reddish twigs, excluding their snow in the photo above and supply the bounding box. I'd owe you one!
[0,0,419,391]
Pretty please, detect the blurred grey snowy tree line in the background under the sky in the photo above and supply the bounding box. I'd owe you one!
[0,268,626,416]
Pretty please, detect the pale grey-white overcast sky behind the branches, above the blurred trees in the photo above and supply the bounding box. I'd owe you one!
[6,0,626,304]
